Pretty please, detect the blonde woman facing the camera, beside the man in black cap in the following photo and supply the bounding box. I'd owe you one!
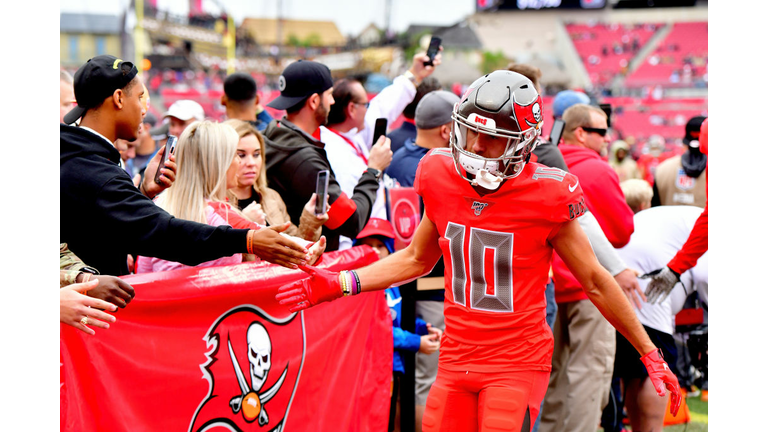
[224,120,328,241]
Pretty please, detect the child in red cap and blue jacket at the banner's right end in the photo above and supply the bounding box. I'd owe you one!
[355,218,443,432]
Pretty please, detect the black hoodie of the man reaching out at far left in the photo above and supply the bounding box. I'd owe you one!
[59,124,248,275]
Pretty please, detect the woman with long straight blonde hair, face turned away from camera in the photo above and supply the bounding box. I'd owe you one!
[136,121,325,273]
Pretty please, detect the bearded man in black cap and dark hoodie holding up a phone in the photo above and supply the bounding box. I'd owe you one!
[264,60,384,251]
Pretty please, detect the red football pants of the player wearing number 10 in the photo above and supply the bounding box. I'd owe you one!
[422,367,549,432]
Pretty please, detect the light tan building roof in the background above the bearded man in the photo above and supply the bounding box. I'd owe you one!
[240,18,347,46]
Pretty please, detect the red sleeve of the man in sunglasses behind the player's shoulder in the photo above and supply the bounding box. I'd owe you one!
[582,160,635,248]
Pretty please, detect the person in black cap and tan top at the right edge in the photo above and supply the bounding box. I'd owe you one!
[651,116,707,208]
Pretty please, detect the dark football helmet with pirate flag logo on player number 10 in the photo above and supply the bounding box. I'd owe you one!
[451,70,543,190]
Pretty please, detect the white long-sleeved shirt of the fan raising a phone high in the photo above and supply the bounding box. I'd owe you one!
[320,75,416,250]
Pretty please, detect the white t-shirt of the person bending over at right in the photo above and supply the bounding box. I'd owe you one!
[617,206,709,334]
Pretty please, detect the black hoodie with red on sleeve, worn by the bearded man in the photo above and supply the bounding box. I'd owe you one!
[264,119,379,251]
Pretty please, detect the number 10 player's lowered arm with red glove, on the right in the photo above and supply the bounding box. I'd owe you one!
[548,221,681,415]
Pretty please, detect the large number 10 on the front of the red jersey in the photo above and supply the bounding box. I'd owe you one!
[445,222,514,312]
